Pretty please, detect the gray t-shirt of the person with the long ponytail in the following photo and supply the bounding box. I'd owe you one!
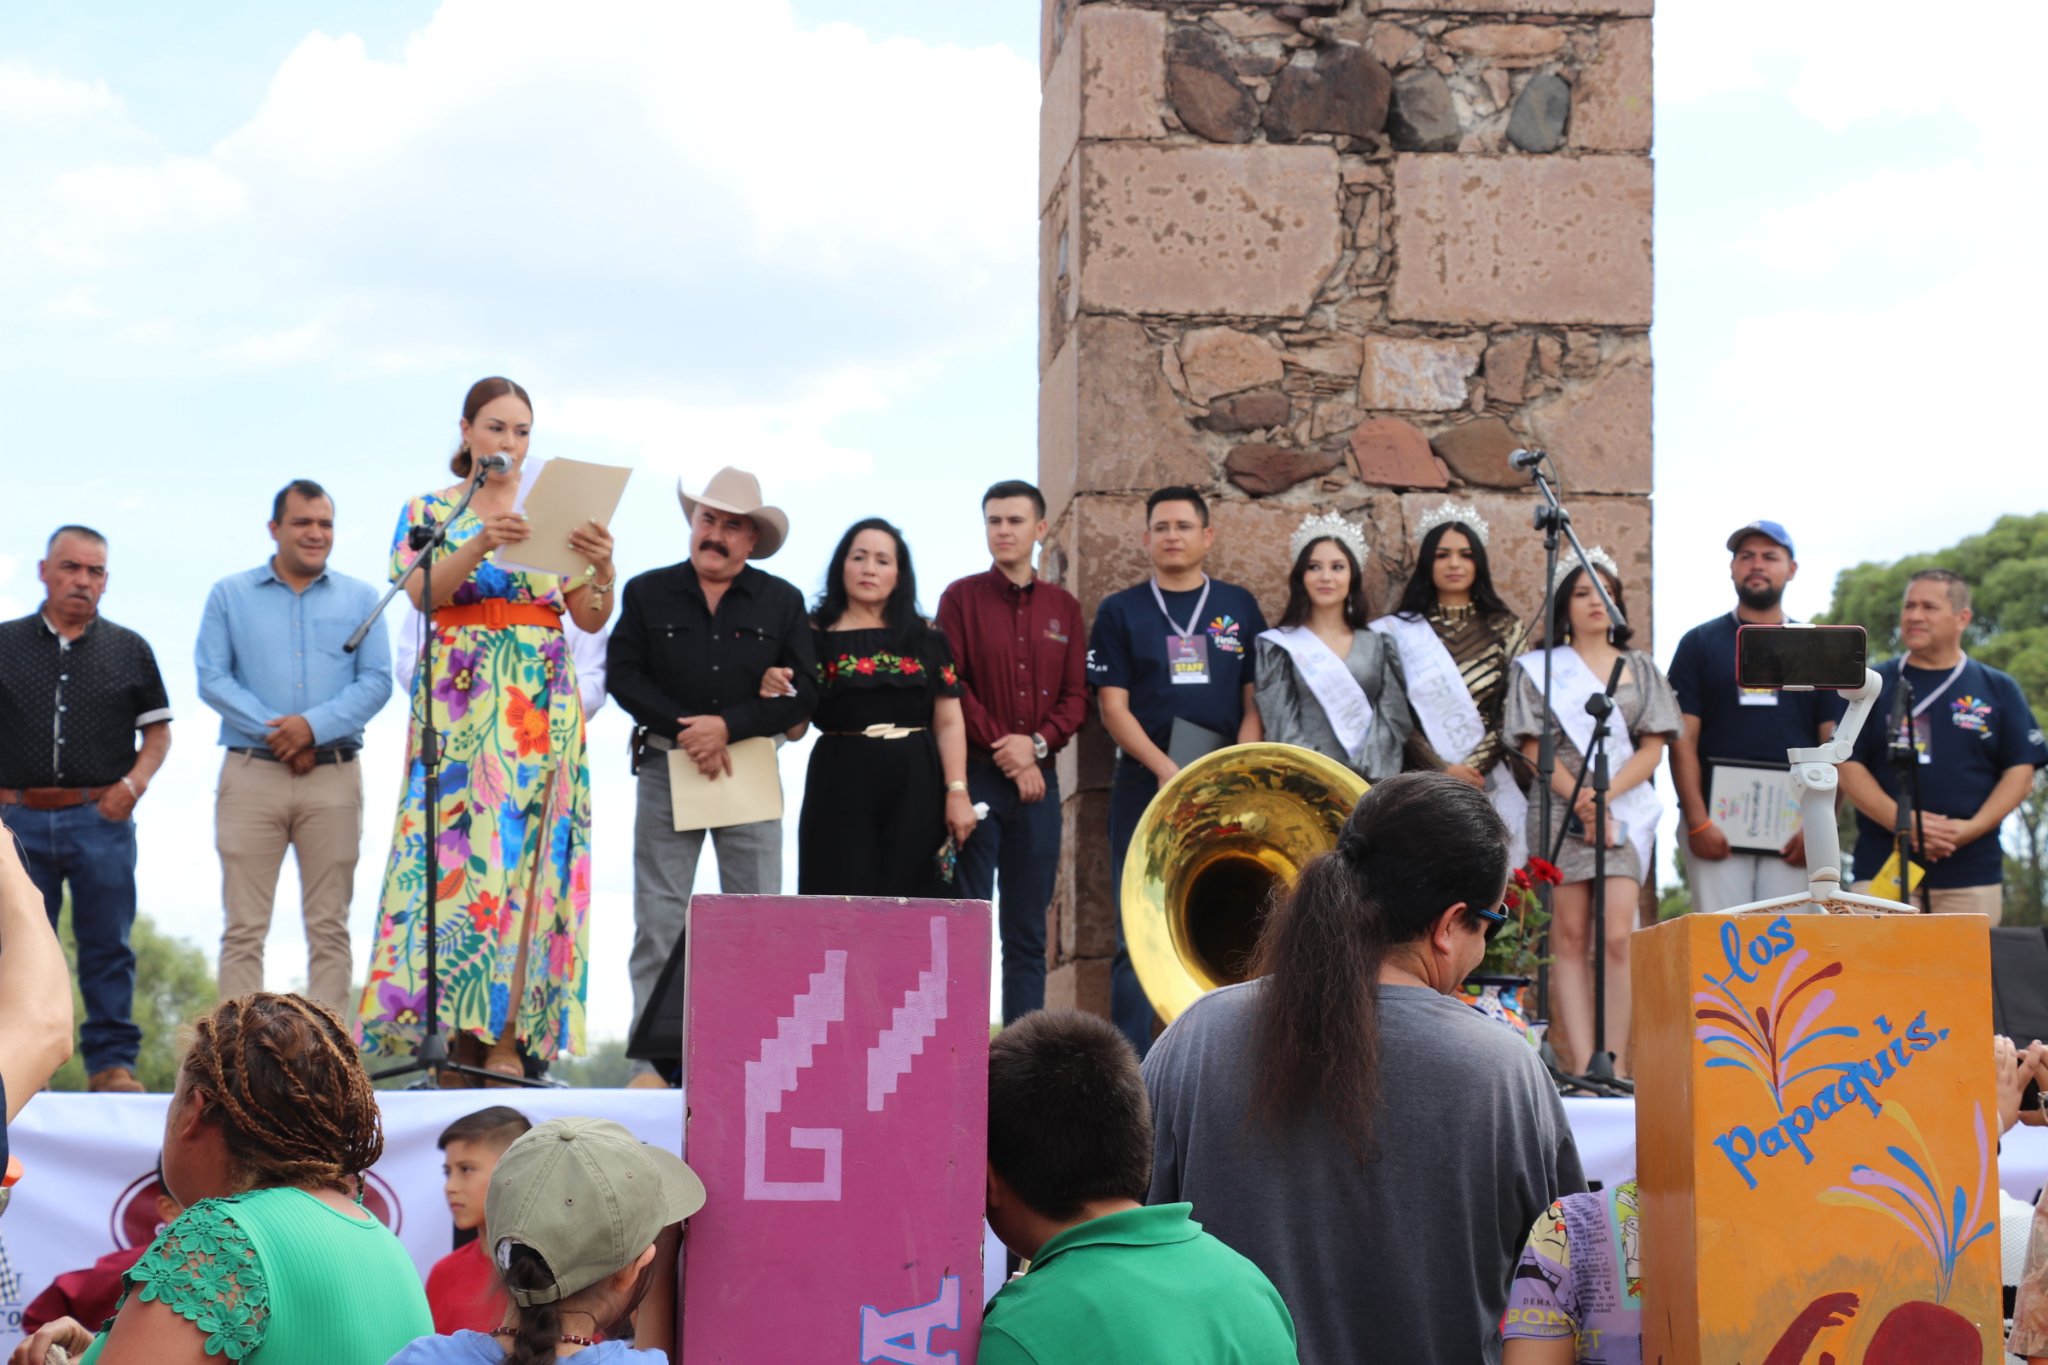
[1145,980,1585,1365]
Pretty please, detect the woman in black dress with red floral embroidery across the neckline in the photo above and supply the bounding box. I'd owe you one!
[797,518,975,896]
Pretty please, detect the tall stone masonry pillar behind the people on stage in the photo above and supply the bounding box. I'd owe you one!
[1038,0,1651,1013]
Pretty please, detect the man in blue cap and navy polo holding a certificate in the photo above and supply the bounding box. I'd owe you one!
[1671,522,1841,915]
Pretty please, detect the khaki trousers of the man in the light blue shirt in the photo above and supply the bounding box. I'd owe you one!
[213,753,362,1021]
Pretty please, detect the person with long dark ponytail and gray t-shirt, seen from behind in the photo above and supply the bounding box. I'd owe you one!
[1145,772,1585,1365]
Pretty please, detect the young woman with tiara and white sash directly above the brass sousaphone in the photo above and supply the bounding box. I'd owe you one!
[1253,512,1415,782]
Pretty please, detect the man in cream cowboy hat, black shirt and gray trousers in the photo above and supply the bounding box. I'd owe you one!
[606,469,817,1085]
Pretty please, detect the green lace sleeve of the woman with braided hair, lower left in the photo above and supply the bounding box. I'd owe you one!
[115,1199,270,1361]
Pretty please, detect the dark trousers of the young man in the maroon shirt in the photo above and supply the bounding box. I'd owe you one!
[954,761,1059,1023]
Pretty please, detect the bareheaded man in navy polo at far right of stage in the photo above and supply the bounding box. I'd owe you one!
[1841,569,2048,923]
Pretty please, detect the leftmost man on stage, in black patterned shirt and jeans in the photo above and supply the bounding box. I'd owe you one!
[0,526,170,1093]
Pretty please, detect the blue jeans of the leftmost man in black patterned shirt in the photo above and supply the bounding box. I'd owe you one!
[4,802,141,1074]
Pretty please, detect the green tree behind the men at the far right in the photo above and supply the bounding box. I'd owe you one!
[1819,512,2048,925]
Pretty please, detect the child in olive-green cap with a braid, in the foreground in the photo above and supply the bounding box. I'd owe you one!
[391,1119,705,1365]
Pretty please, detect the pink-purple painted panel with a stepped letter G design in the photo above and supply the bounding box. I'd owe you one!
[682,896,991,1365]
